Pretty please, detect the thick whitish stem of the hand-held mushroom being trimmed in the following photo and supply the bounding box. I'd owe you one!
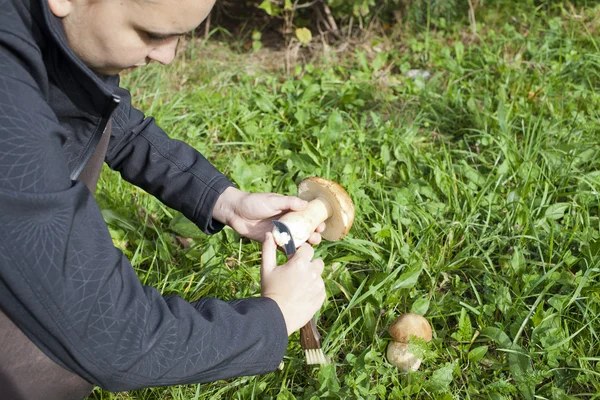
[279,197,333,247]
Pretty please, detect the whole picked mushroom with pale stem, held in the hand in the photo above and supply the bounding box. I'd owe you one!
[273,176,354,247]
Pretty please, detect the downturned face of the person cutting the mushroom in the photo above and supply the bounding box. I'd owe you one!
[48,0,215,75]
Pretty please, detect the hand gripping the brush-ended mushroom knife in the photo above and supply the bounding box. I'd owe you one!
[260,232,325,336]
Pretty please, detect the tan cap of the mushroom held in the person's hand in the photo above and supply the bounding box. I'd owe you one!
[298,176,354,241]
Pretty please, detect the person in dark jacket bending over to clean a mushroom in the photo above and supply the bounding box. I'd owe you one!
[0,0,325,400]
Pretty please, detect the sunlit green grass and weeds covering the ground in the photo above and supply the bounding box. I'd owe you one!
[91,2,600,400]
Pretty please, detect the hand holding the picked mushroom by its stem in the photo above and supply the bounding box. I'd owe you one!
[213,187,325,245]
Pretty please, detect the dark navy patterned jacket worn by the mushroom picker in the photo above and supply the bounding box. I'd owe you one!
[0,0,287,391]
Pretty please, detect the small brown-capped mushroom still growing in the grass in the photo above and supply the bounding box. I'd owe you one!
[387,313,432,371]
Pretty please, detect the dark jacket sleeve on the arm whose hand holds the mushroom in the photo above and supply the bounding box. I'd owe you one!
[106,83,233,234]
